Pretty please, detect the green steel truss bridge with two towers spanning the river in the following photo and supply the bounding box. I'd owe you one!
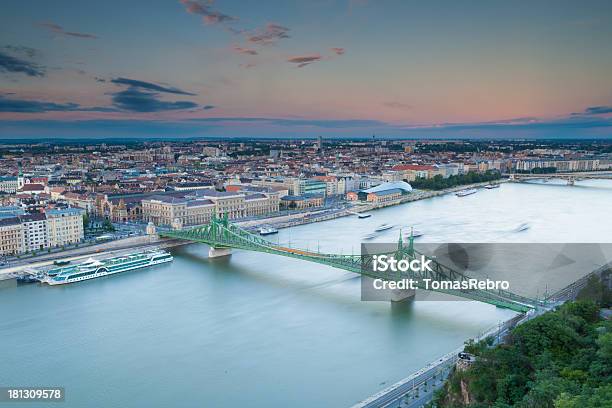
[159,217,545,313]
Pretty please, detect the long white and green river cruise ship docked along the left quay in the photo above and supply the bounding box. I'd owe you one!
[42,249,174,285]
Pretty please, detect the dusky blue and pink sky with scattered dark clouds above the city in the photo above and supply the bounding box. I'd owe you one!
[0,0,612,139]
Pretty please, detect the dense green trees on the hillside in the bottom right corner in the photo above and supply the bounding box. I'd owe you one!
[434,301,612,408]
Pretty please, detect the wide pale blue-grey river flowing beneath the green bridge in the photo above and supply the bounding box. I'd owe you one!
[0,181,612,407]
